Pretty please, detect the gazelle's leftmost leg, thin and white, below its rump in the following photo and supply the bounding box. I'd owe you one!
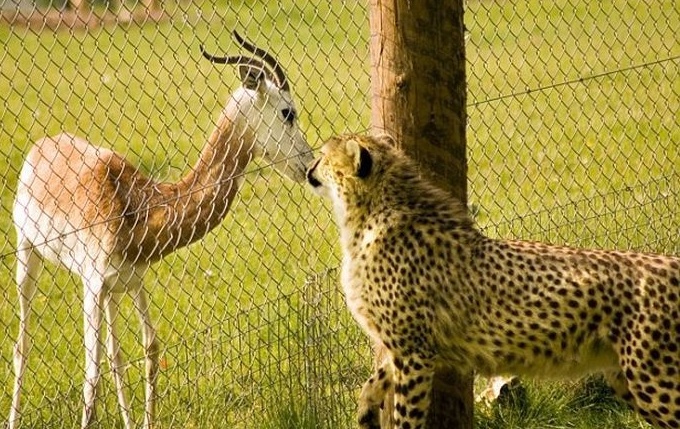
[9,241,42,429]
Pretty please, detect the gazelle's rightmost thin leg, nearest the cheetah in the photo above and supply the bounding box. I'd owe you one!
[134,287,159,429]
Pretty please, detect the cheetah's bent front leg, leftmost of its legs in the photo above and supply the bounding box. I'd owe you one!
[358,359,393,429]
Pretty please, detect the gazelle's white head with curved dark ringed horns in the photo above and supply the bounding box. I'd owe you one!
[201,32,313,182]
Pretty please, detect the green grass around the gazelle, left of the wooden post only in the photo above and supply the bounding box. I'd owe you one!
[0,2,370,428]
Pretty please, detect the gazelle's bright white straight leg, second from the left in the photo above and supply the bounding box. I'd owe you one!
[82,275,105,428]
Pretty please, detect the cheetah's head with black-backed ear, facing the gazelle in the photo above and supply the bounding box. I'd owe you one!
[307,134,395,200]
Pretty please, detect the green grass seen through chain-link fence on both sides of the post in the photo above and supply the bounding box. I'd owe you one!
[0,0,680,428]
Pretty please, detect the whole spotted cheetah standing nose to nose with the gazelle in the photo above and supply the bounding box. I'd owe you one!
[307,134,680,429]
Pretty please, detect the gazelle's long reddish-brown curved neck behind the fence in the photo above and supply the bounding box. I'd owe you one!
[117,112,254,262]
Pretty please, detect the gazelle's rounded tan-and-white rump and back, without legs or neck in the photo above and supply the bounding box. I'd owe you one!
[14,134,133,269]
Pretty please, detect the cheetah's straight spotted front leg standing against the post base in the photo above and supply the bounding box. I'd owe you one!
[393,354,434,429]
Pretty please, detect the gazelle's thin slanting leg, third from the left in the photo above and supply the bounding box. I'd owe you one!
[104,293,133,429]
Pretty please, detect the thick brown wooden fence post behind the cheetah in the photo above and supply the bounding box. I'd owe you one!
[370,0,473,429]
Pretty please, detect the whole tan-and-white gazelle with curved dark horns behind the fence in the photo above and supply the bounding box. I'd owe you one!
[9,32,312,428]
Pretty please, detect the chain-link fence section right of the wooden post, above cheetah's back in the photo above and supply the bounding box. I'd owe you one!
[465,0,680,254]
